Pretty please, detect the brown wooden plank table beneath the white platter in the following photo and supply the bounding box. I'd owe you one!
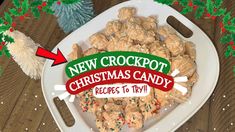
[0,0,235,132]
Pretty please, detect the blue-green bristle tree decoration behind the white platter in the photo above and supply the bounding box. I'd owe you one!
[52,0,94,33]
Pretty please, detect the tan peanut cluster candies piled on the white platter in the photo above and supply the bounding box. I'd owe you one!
[69,7,198,132]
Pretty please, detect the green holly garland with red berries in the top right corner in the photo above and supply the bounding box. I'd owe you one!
[154,0,235,75]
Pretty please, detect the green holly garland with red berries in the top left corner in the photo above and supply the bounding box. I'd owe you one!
[0,0,80,58]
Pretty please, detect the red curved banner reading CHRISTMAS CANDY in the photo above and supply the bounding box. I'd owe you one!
[66,66,174,95]
